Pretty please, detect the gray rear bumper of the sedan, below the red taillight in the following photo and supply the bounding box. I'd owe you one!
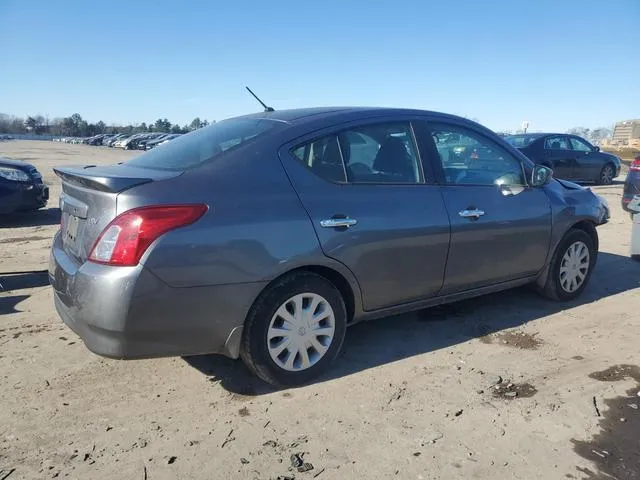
[49,234,264,359]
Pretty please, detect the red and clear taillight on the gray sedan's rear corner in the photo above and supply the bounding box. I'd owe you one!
[89,205,207,266]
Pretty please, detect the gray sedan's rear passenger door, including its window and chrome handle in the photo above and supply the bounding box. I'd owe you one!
[280,118,450,311]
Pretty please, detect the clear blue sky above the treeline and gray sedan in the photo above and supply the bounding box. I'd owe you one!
[0,0,640,130]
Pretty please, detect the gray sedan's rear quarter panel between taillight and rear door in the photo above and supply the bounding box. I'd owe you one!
[118,139,357,304]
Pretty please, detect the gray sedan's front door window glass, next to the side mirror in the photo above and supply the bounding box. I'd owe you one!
[431,124,526,185]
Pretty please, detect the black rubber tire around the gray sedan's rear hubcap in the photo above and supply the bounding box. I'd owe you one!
[240,272,347,387]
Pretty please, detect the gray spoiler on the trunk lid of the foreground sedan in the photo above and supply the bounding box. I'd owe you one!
[53,165,153,193]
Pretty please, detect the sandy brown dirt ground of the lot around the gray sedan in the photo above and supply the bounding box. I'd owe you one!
[0,142,640,480]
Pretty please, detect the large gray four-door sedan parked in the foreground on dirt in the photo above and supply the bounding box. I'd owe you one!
[49,108,609,385]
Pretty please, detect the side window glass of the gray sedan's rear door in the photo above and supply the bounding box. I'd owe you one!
[292,123,422,183]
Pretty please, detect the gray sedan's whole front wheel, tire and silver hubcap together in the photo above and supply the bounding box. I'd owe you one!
[542,229,598,301]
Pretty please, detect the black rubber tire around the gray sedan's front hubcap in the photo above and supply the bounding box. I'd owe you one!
[541,229,598,302]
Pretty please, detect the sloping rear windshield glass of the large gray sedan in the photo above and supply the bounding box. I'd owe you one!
[125,118,285,171]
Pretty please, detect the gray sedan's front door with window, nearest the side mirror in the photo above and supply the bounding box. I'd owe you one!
[428,123,551,294]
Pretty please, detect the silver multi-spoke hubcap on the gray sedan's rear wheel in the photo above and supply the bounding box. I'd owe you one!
[266,293,336,372]
